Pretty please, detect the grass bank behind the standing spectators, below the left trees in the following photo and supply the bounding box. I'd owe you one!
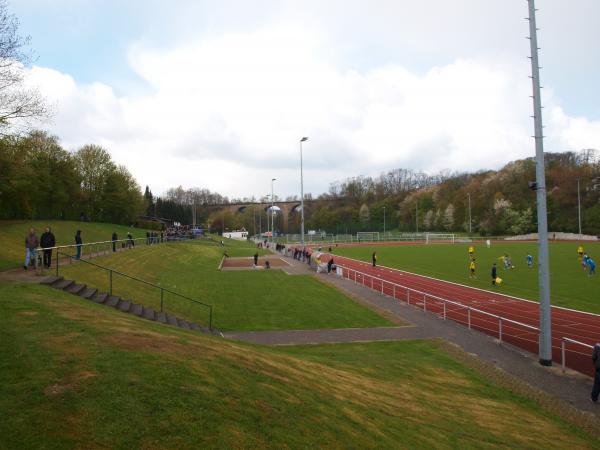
[0,220,146,270]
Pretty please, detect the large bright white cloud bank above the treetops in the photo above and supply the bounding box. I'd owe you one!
[30,26,600,196]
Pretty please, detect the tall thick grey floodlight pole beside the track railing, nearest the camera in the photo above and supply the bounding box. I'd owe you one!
[527,0,552,366]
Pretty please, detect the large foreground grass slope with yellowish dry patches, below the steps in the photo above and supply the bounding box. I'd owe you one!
[0,283,600,449]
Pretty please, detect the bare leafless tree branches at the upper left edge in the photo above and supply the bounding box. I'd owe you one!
[0,0,49,134]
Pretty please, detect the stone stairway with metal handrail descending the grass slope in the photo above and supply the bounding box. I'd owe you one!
[41,276,222,336]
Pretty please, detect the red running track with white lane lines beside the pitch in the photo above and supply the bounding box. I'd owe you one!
[321,254,600,376]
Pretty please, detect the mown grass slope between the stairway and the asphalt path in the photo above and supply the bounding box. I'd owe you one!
[61,242,392,331]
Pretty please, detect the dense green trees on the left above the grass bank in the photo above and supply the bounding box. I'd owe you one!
[0,131,144,224]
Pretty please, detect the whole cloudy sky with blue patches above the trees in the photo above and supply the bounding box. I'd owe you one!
[9,0,600,198]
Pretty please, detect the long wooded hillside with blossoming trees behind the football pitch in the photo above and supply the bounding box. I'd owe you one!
[156,150,600,235]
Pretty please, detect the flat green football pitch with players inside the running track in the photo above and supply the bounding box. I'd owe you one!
[334,242,600,313]
